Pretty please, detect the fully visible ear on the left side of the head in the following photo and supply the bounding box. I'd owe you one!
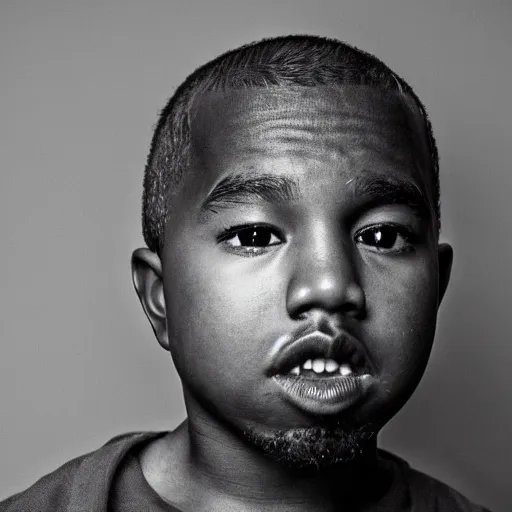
[132,248,169,350]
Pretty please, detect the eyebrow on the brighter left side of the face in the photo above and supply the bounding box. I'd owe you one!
[200,173,299,220]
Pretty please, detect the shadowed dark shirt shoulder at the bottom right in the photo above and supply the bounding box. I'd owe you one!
[381,451,490,512]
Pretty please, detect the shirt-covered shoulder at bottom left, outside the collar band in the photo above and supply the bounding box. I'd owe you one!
[0,432,165,512]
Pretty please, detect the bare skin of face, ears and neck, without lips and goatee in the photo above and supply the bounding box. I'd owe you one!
[132,86,452,511]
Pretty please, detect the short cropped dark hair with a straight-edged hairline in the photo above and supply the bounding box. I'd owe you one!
[142,35,440,252]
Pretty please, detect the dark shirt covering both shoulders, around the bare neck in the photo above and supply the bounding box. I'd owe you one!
[0,432,489,512]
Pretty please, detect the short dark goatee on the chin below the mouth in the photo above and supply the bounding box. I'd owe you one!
[244,423,378,471]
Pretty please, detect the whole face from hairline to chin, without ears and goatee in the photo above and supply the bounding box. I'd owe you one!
[155,86,449,462]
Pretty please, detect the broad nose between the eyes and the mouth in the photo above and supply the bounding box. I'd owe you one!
[286,229,366,319]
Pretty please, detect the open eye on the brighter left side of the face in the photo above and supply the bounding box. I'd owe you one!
[218,225,284,256]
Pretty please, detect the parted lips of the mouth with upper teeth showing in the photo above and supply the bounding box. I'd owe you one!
[267,330,375,415]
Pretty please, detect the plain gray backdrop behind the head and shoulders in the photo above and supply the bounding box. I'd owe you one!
[0,0,512,512]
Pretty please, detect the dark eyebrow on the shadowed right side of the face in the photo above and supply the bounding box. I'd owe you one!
[349,173,432,220]
